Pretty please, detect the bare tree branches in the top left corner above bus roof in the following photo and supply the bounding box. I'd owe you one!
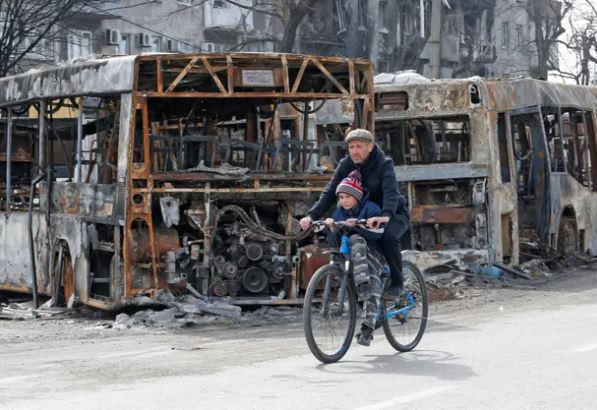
[0,0,105,77]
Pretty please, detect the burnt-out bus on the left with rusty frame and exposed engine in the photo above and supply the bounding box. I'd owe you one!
[0,53,373,309]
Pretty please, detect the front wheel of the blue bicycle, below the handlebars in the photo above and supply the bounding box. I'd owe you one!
[303,265,357,363]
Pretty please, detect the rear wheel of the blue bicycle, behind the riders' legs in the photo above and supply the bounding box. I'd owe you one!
[382,261,428,352]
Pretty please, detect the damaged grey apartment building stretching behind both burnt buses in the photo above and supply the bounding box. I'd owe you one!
[15,0,559,78]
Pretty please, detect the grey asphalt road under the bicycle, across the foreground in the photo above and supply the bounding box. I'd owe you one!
[0,268,597,410]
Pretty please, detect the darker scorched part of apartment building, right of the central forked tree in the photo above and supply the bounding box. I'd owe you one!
[298,0,558,78]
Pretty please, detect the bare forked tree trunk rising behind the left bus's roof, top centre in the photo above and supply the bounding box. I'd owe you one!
[225,0,318,53]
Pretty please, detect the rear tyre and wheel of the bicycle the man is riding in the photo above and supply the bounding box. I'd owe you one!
[382,261,429,352]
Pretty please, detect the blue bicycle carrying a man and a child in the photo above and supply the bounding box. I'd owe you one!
[303,220,428,363]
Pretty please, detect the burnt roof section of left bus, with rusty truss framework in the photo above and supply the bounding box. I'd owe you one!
[0,53,373,107]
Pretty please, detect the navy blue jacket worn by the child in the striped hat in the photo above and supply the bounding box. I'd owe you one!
[326,194,383,251]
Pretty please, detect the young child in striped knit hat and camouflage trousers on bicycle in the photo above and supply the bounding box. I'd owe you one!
[325,171,385,346]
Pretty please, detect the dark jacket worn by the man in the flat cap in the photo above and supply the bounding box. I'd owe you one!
[308,144,408,220]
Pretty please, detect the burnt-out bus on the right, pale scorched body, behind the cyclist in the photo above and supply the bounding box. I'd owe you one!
[375,78,597,268]
